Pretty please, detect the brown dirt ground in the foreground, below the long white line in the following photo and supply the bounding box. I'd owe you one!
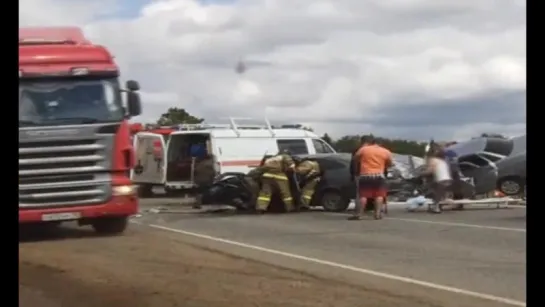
[19,227,438,307]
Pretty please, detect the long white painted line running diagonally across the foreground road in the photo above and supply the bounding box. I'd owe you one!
[138,222,526,307]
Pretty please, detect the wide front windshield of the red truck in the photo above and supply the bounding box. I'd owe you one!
[19,78,124,126]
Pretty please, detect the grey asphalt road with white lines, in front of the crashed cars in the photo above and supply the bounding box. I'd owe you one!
[134,199,526,306]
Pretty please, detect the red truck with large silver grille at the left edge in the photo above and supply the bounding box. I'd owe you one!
[19,27,142,234]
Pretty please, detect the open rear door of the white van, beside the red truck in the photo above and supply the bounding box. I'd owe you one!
[131,132,166,185]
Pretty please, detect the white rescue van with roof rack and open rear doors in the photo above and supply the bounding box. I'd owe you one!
[131,118,335,195]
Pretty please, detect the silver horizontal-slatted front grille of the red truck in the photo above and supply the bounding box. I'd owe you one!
[19,138,111,209]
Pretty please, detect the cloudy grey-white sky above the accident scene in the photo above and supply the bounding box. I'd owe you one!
[19,0,526,140]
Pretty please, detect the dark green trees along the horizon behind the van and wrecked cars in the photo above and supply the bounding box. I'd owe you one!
[151,108,503,156]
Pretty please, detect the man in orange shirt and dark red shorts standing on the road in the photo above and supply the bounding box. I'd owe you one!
[350,135,392,220]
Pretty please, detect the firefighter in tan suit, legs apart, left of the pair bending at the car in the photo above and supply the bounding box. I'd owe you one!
[256,151,295,213]
